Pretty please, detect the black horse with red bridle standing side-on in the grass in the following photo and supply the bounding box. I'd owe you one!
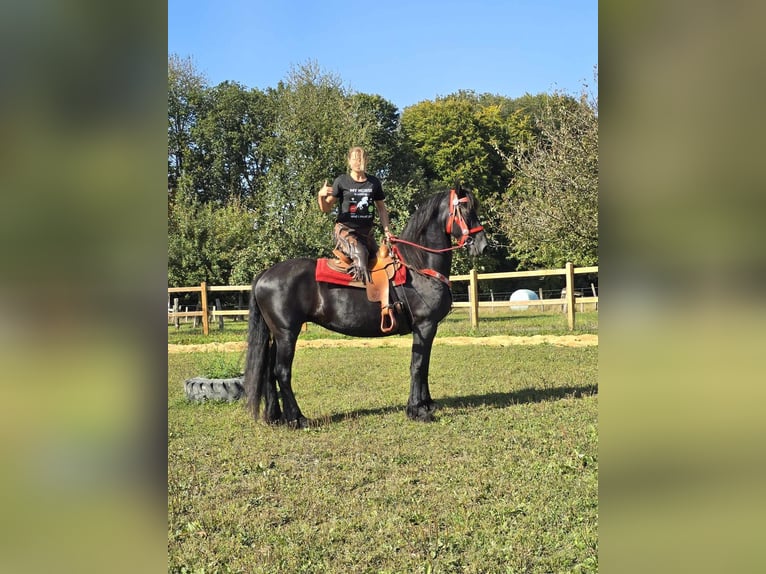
[243,185,487,427]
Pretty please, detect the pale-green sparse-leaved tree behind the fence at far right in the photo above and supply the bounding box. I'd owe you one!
[495,93,598,268]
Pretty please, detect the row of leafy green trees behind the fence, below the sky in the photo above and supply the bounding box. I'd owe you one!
[168,55,598,286]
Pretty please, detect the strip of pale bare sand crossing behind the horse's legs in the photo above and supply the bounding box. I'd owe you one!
[168,335,598,354]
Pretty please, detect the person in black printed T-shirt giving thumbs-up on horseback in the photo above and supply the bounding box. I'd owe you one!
[317,146,391,283]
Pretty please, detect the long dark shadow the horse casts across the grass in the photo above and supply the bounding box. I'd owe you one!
[310,385,598,427]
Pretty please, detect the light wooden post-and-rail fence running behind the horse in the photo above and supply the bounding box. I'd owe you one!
[168,263,598,335]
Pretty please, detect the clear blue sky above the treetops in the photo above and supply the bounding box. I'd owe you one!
[168,0,598,109]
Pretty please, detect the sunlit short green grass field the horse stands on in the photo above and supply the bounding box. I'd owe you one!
[168,314,598,573]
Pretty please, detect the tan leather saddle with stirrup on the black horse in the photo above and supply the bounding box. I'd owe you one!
[317,244,404,333]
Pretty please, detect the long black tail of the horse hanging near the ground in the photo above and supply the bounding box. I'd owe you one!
[242,277,273,419]
